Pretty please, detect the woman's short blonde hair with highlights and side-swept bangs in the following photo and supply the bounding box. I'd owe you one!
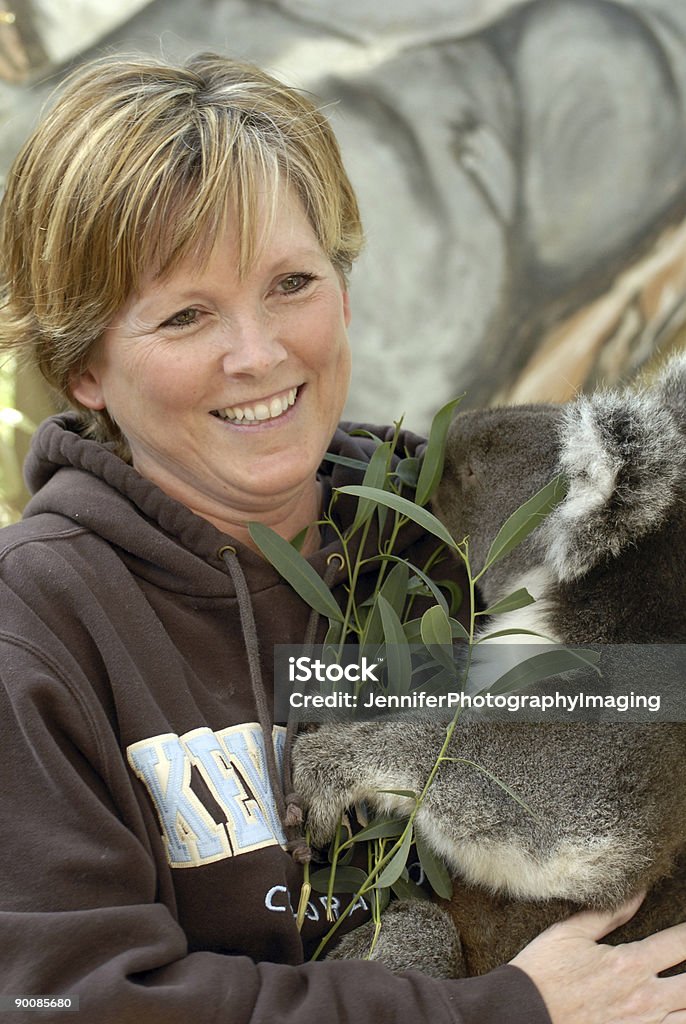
[0,53,362,442]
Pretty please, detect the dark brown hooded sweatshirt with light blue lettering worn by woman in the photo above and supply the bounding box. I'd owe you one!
[0,414,549,1024]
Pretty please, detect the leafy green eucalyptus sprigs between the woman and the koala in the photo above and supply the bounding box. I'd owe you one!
[250,399,574,959]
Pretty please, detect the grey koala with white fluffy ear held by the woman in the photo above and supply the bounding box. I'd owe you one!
[294,357,686,977]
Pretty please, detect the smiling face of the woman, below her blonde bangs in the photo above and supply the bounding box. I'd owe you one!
[73,190,350,527]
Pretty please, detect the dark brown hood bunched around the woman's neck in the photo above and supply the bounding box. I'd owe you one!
[24,413,423,597]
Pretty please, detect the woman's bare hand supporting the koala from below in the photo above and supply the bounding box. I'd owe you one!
[512,897,686,1024]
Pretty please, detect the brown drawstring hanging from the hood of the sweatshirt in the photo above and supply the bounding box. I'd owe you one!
[217,545,344,864]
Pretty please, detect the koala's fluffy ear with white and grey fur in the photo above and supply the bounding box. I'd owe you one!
[542,357,686,581]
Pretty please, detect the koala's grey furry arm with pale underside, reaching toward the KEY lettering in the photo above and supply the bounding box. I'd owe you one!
[294,717,686,906]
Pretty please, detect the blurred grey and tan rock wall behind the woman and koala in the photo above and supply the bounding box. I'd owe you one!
[0,0,686,518]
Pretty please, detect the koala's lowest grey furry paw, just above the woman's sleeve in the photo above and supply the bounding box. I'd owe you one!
[328,899,467,978]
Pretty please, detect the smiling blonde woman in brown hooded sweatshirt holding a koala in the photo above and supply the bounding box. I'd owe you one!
[0,56,686,1024]
